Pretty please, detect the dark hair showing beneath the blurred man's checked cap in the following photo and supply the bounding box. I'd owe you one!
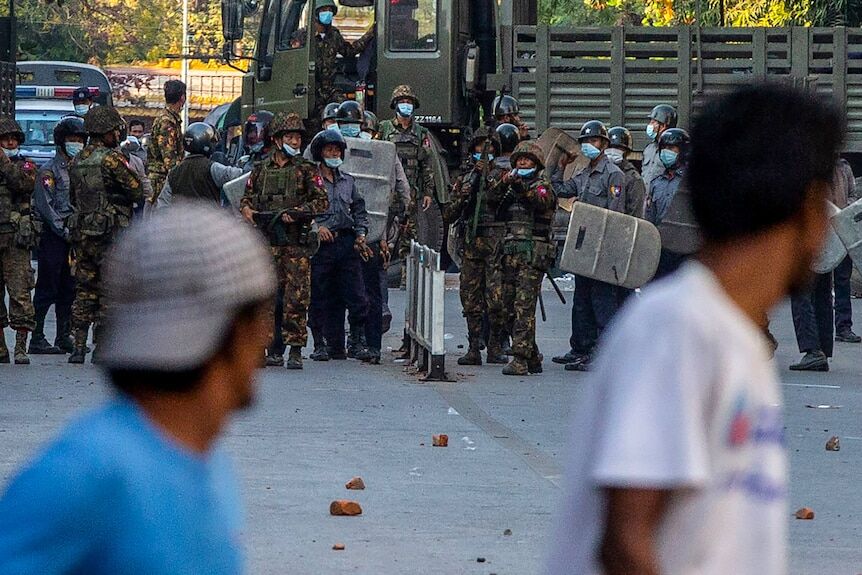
[108,302,267,396]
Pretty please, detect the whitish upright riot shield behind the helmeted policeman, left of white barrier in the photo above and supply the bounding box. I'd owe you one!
[341,143,397,244]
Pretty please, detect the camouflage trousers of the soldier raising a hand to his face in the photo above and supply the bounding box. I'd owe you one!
[503,253,545,360]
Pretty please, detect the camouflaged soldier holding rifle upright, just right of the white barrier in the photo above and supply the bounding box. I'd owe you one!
[443,132,507,365]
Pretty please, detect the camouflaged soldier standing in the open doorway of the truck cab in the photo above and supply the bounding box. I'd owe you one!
[311,0,374,122]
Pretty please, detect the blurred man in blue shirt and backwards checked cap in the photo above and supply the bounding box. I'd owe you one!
[0,202,275,575]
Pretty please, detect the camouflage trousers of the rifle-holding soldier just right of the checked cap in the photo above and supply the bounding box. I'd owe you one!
[268,246,311,347]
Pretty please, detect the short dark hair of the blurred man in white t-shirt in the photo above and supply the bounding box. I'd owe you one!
[687,83,845,242]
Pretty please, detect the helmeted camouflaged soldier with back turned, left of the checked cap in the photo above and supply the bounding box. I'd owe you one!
[67,106,143,363]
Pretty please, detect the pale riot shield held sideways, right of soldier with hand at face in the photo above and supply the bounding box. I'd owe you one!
[560,202,661,289]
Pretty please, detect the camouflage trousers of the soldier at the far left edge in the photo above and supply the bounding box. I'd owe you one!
[0,233,36,331]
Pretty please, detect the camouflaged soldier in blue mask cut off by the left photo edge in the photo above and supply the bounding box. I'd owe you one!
[0,118,37,365]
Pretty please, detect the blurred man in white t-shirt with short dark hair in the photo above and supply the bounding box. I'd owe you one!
[547,85,844,575]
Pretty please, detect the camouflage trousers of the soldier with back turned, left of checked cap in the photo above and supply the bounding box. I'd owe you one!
[72,236,111,334]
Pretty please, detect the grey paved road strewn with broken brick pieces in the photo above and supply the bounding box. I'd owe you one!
[0,291,862,575]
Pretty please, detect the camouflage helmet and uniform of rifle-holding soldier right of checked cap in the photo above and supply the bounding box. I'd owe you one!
[240,114,329,353]
